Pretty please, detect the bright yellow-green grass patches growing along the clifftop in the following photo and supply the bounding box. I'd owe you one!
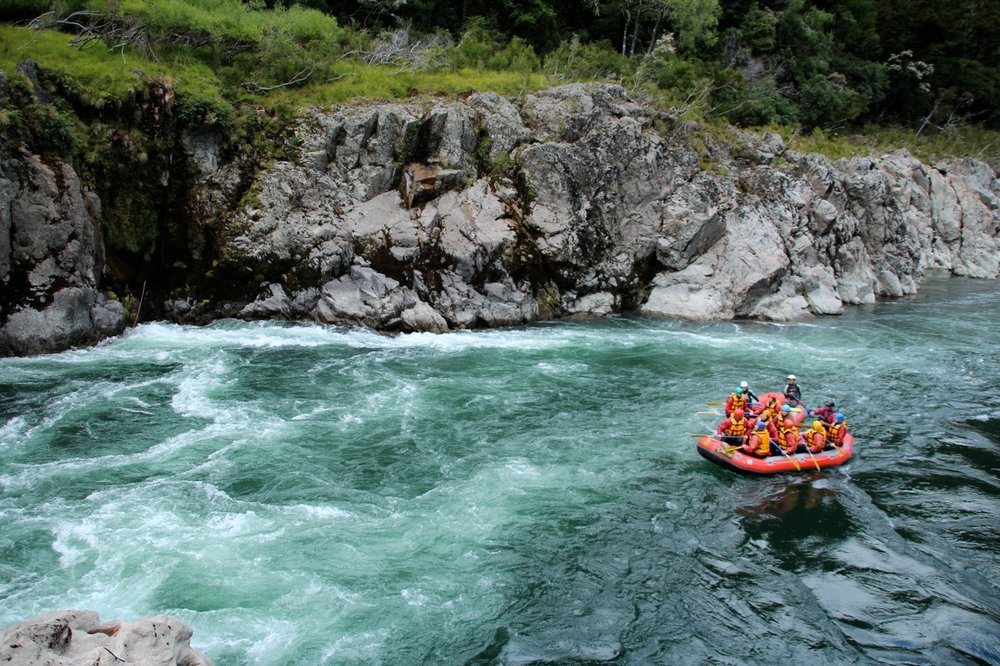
[0,12,1000,169]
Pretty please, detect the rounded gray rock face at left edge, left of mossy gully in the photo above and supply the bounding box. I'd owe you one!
[0,148,125,356]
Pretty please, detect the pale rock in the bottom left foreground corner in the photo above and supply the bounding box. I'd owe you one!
[0,610,212,666]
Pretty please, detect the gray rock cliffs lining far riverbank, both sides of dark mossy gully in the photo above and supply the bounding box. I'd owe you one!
[0,85,1000,353]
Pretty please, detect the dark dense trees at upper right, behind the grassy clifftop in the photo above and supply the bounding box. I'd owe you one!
[307,0,1000,127]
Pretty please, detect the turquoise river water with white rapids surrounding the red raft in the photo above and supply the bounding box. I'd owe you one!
[0,279,1000,666]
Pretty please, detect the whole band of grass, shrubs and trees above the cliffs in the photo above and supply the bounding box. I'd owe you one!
[0,0,1000,141]
